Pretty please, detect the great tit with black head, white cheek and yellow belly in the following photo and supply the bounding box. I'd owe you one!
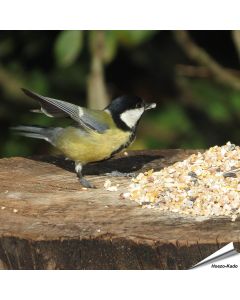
[13,89,156,188]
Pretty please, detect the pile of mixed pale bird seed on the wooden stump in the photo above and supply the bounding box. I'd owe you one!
[123,142,240,221]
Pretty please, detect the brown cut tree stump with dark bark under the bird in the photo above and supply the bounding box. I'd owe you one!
[0,150,240,269]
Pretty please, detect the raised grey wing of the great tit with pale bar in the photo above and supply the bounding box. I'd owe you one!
[22,89,109,133]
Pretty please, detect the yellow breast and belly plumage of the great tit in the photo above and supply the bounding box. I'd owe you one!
[55,127,131,164]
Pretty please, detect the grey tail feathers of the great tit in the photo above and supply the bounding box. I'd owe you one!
[11,126,49,142]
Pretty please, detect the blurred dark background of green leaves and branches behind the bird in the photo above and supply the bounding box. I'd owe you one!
[0,31,240,157]
